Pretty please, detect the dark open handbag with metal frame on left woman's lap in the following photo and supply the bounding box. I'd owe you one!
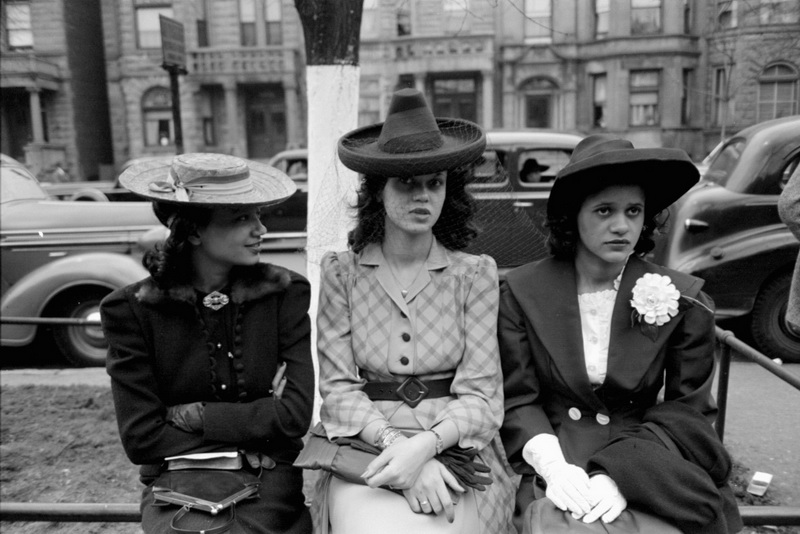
[148,460,261,534]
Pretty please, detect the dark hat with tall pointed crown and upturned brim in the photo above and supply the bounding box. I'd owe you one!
[339,89,486,177]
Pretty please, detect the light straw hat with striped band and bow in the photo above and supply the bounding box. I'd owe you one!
[119,153,297,207]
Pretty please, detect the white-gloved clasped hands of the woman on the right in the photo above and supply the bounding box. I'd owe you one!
[543,463,628,523]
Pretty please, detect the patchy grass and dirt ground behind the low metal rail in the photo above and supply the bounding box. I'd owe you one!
[0,385,796,534]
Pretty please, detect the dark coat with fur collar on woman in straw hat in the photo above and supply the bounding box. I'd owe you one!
[100,263,314,480]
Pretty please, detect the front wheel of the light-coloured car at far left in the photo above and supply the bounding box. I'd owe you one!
[51,287,110,367]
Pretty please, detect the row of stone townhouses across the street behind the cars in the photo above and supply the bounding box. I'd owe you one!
[0,0,800,177]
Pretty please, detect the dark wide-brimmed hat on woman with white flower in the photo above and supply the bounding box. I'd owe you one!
[547,134,700,219]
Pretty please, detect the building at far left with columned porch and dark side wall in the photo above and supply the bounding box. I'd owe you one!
[0,0,113,178]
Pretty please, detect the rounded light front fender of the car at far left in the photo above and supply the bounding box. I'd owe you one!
[0,252,148,347]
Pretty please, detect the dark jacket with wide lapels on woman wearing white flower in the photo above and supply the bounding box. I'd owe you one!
[498,256,716,474]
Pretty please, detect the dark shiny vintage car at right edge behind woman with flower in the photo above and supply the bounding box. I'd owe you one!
[653,116,800,362]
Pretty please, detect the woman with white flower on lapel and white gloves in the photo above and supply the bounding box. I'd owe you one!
[498,134,741,532]
